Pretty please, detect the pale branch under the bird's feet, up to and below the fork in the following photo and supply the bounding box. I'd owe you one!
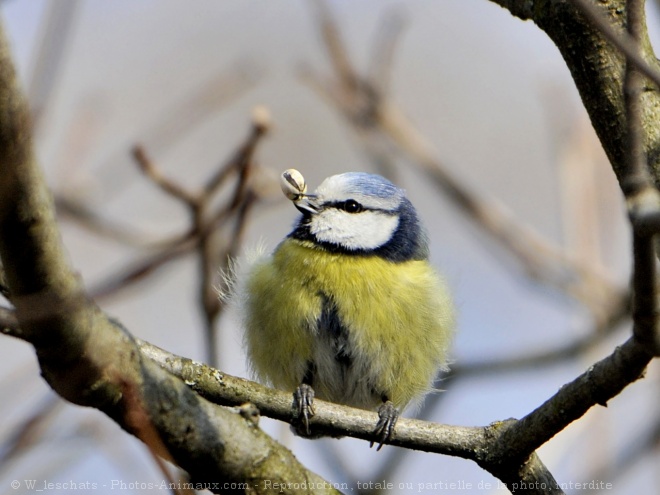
[139,341,563,495]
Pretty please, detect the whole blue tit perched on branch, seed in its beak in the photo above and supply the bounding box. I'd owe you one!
[243,169,454,448]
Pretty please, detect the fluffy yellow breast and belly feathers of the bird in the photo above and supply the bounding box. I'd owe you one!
[246,239,454,408]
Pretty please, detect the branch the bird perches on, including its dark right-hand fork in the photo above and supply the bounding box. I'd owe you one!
[4,294,652,493]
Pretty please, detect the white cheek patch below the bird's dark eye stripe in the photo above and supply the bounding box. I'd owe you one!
[309,208,399,250]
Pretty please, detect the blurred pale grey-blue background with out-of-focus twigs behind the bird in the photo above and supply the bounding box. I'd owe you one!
[0,0,660,494]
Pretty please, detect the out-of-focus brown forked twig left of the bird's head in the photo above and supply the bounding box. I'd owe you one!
[71,107,270,365]
